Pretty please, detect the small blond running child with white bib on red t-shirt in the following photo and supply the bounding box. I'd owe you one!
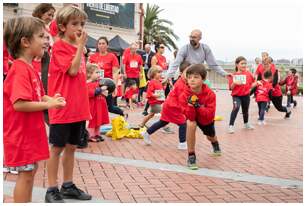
[139,66,165,128]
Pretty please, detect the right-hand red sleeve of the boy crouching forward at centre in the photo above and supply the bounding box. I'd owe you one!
[196,92,216,123]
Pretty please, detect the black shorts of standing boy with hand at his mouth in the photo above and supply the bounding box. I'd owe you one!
[49,121,86,147]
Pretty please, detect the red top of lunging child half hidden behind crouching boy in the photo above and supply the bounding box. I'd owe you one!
[160,77,188,124]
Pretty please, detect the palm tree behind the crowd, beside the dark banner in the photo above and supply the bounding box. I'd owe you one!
[144,4,179,50]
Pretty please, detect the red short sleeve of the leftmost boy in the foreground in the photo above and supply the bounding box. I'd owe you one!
[10,63,33,104]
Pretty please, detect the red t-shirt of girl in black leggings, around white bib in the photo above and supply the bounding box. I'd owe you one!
[229,71,254,96]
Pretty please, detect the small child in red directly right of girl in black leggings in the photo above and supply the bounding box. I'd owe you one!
[251,70,273,125]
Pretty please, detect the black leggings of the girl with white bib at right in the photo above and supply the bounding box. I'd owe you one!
[229,95,250,125]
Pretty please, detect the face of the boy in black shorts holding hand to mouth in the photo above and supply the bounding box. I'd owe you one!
[61,18,85,41]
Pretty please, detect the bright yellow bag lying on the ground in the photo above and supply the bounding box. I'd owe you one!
[111,116,129,140]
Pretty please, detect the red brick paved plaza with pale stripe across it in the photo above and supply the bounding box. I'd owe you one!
[3,91,303,203]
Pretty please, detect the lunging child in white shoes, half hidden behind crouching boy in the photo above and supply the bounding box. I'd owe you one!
[141,62,190,150]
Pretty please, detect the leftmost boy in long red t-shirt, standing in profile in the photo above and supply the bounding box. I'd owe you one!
[3,17,66,203]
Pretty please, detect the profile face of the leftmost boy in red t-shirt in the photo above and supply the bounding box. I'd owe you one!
[29,29,48,57]
